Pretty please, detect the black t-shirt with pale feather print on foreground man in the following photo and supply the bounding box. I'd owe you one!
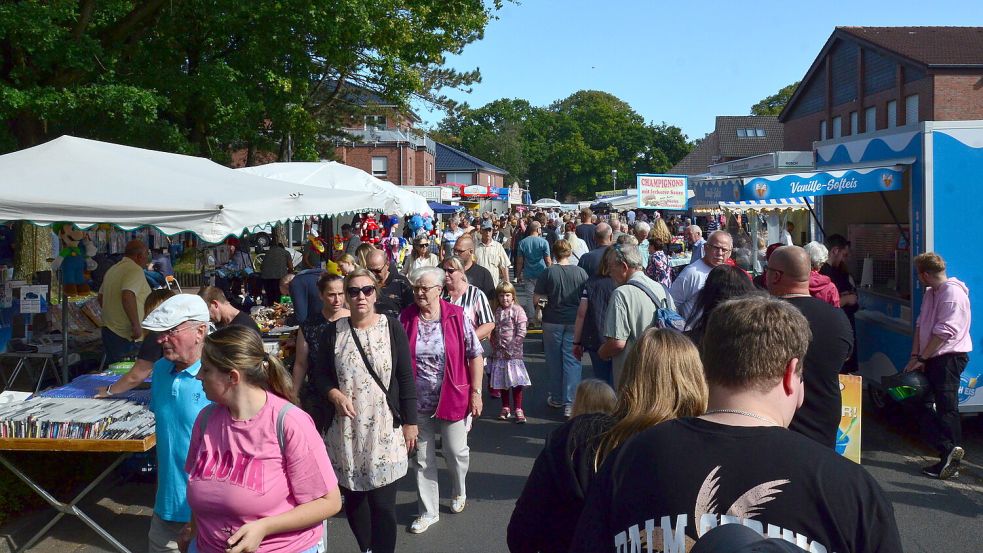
[571,419,901,553]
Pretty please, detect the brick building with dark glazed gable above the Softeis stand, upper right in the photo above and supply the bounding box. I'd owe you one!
[779,27,983,150]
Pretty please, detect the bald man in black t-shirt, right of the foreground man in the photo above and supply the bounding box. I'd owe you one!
[765,246,853,448]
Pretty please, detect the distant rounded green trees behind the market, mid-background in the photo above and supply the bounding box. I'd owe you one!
[433,90,690,199]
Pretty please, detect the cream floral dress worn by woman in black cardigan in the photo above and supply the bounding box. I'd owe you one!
[324,317,408,491]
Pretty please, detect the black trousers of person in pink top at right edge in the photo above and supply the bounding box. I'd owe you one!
[925,353,969,455]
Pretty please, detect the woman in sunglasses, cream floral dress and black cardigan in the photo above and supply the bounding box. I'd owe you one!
[312,269,417,553]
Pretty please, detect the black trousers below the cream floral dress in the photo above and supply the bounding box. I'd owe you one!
[341,480,399,553]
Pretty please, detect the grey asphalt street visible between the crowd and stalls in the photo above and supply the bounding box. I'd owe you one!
[0,335,983,553]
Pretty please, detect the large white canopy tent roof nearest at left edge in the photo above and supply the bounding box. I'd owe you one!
[0,136,374,243]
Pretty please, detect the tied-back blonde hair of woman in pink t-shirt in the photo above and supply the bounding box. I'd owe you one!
[201,325,297,404]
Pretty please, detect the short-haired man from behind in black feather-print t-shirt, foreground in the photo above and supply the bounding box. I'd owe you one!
[571,296,901,553]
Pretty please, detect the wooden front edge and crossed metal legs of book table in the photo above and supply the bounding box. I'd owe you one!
[0,434,157,553]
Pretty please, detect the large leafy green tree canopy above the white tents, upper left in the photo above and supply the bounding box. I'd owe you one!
[0,0,501,160]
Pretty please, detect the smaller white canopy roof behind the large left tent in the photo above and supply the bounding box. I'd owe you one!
[239,161,433,216]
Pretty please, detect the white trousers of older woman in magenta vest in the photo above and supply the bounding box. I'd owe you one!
[416,413,471,516]
